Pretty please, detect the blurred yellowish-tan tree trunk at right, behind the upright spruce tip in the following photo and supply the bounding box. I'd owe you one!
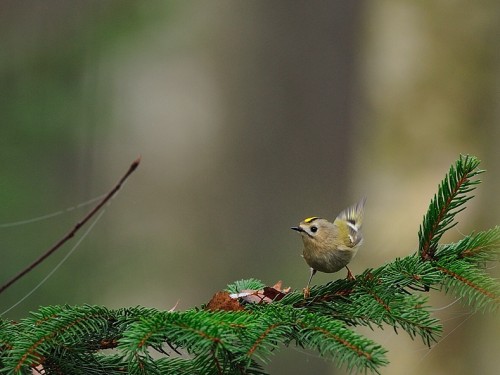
[362,1,500,374]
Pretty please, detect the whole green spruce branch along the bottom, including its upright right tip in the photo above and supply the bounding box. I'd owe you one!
[0,156,500,375]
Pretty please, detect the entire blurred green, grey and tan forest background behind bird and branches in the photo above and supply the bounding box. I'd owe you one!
[0,0,500,375]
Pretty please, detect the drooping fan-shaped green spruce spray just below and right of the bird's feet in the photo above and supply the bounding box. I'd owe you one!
[280,262,442,346]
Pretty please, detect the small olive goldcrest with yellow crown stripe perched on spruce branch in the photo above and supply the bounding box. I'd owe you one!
[291,198,366,298]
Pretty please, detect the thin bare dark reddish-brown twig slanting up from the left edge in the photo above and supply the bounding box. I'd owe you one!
[0,157,141,294]
